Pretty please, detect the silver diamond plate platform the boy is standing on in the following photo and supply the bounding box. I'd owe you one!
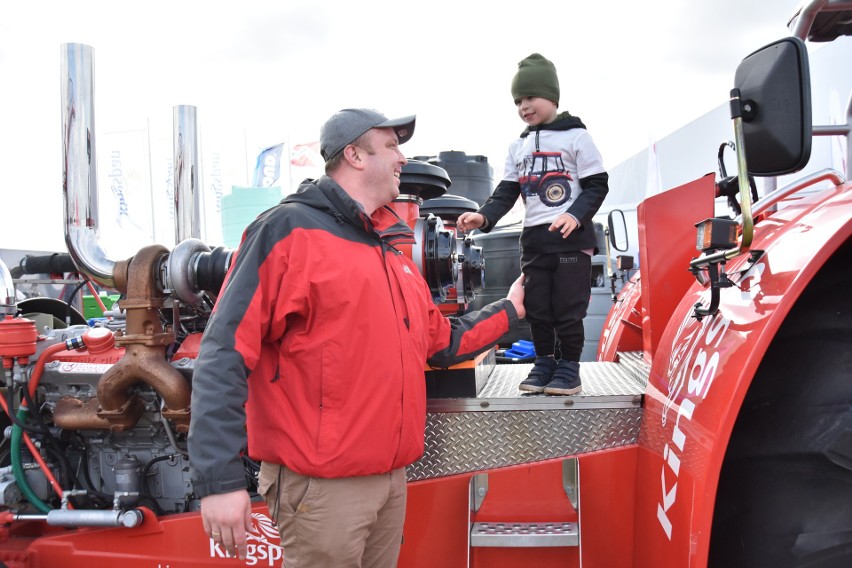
[407,353,650,481]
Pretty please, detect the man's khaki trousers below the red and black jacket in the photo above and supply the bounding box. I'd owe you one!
[258,462,406,568]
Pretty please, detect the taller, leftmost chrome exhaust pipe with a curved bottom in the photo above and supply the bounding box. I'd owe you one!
[60,43,115,288]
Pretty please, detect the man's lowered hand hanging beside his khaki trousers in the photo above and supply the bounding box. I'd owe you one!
[201,489,251,560]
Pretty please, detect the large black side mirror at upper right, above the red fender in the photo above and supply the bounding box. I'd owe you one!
[734,37,812,176]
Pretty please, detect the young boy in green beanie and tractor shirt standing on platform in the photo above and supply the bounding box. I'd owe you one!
[457,53,609,395]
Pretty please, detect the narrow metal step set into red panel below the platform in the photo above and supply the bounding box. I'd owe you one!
[470,523,580,548]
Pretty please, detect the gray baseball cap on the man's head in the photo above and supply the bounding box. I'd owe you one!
[320,108,415,162]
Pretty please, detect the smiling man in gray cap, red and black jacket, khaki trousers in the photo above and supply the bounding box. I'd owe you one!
[189,109,524,568]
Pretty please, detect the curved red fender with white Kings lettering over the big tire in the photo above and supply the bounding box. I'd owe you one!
[635,185,852,567]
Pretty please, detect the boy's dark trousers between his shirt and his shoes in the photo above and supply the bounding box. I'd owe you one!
[521,251,592,361]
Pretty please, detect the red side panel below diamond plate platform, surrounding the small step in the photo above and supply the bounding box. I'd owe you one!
[399,446,638,568]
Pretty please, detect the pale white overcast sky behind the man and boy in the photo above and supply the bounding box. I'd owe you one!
[0,0,799,249]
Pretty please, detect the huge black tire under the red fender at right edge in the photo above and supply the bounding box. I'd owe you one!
[708,242,852,568]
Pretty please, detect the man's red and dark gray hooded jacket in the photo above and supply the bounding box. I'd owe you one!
[189,176,517,497]
